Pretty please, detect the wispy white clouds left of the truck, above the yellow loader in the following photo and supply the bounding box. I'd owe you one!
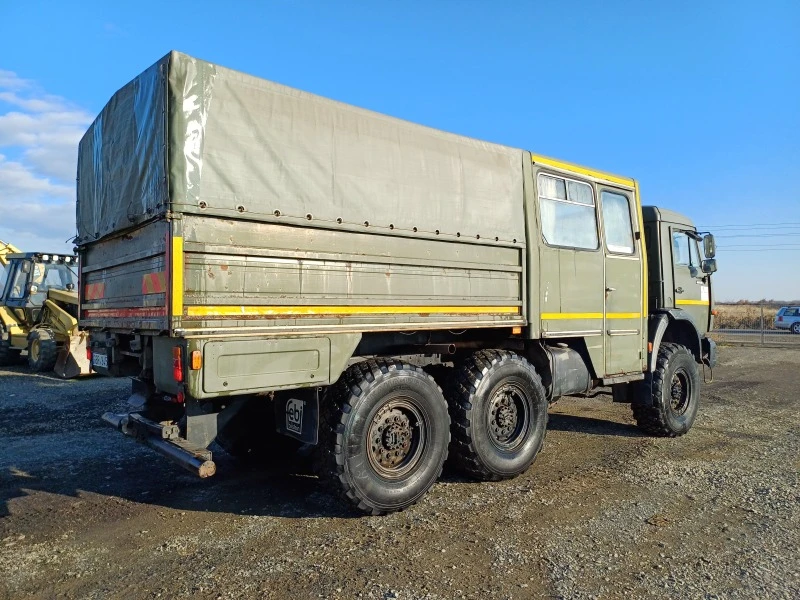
[0,70,92,250]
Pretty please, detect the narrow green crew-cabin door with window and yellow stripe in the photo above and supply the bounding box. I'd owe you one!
[600,187,645,376]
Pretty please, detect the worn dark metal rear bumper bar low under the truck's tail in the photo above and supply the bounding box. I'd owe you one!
[102,412,217,479]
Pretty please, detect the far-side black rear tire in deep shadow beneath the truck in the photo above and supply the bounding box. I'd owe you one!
[215,396,302,465]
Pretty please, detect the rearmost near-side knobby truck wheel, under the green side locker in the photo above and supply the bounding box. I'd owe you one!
[317,359,450,515]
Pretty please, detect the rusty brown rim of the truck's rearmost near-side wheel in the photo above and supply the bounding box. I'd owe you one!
[367,397,426,480]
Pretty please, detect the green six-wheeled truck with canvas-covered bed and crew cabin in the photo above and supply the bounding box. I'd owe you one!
[77,52,716,514]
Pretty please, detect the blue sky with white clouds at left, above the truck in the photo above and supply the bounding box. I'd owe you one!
[0,0,800,300]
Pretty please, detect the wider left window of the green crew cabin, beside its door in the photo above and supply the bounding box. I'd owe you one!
[537,173,598,250]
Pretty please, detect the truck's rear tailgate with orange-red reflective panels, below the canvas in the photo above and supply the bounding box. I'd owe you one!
[80,219,170,331]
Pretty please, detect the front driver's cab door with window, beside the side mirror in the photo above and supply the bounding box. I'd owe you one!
[670,227,711,335]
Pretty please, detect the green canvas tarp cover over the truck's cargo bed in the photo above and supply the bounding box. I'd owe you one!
[77,52,525,244]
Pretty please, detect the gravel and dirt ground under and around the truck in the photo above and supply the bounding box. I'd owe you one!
[0,347,800,600]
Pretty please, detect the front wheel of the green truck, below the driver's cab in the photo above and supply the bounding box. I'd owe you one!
[631,343,700,437]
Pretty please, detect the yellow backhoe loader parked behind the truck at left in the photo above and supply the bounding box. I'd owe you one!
[0,241,90,379]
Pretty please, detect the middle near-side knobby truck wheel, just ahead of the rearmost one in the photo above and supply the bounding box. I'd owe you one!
[446,350,547,481]
